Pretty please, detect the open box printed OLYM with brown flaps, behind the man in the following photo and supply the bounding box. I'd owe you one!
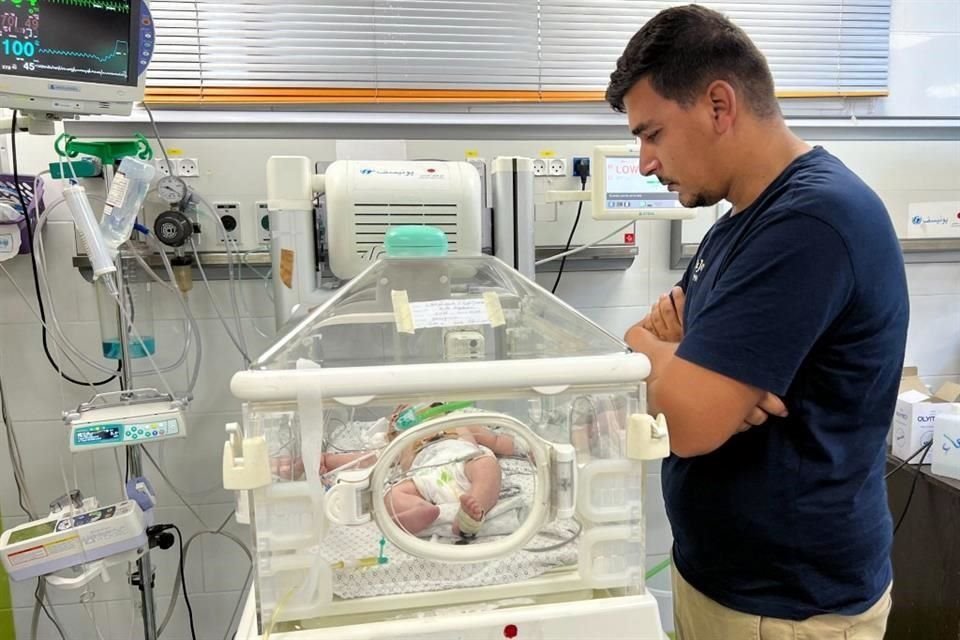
[892,367,960,464]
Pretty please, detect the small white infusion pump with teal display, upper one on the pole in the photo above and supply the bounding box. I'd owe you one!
[64,389,187,453]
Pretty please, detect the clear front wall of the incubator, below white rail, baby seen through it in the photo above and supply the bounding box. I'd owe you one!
[245,386,644,632]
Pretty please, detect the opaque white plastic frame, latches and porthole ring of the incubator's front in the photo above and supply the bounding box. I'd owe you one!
[224,353,669,640]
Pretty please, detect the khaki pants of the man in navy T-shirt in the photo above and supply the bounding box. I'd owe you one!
[673,567,891,640]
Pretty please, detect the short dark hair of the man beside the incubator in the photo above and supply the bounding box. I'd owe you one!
[606,4,780,118]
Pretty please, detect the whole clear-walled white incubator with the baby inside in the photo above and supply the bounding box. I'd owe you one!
[229,256,669,640]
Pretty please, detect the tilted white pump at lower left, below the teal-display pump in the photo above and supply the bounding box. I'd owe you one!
[0,498,147,588]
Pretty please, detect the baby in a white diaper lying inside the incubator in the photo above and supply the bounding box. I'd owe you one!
[320,405,519,538]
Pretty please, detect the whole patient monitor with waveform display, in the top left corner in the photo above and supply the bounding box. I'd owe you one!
[0,0,154,133]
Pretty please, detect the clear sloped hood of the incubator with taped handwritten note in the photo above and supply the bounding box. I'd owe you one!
[254,256,627,369]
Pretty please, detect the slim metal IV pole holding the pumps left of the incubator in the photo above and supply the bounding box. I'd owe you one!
[103,165,157,640]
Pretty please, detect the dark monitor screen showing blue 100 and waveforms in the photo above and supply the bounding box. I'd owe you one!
[0,0,140,86]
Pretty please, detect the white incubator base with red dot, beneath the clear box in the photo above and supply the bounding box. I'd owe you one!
[236,592,667,640]
